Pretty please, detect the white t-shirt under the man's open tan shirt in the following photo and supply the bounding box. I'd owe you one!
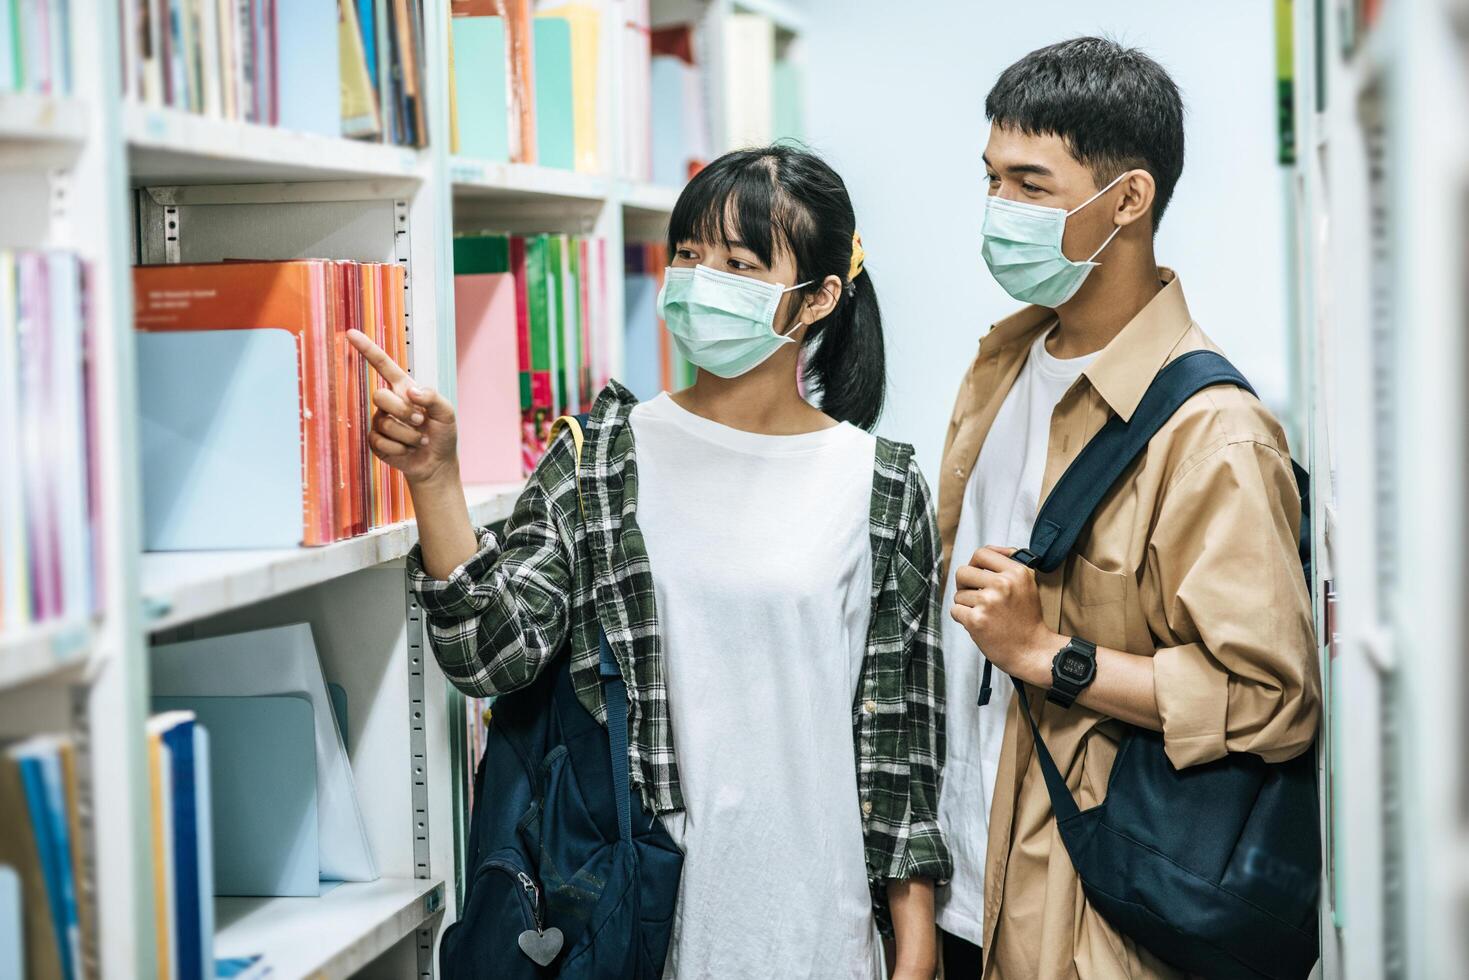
[936,331,1096,945]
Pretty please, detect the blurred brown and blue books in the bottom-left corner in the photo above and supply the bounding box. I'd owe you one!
[0,735,87,980]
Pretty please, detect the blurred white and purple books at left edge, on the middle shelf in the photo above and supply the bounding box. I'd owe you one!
[0,250,100,632]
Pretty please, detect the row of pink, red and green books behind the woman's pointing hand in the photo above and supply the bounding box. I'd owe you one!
[454,234,611,482]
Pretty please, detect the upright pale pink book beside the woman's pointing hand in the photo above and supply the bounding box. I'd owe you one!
[454,272,521,483]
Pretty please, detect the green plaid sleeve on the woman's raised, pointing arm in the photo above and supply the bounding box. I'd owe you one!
[408,436,576,698]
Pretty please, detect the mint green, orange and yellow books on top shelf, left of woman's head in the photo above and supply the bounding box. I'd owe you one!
[450,0,611,173]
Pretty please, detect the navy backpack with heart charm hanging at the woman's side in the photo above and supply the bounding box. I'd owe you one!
[439,416,683,980]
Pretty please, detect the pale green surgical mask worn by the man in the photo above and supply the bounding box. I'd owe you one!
[983,172,1127,310]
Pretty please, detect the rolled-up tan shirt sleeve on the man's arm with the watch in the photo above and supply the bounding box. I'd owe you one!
[1144,441,1321,768]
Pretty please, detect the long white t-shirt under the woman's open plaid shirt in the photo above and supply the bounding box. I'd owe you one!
[632,394,881,980]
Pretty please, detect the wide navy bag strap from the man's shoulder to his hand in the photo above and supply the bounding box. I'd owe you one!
[1015,350,1255,572]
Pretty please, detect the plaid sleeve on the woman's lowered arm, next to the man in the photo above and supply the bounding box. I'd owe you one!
[889,461,953,883]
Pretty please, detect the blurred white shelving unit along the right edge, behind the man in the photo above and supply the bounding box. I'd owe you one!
[1291,0,1469,979]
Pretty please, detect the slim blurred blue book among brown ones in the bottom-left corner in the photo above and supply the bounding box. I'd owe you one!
[10,736,81,980]
